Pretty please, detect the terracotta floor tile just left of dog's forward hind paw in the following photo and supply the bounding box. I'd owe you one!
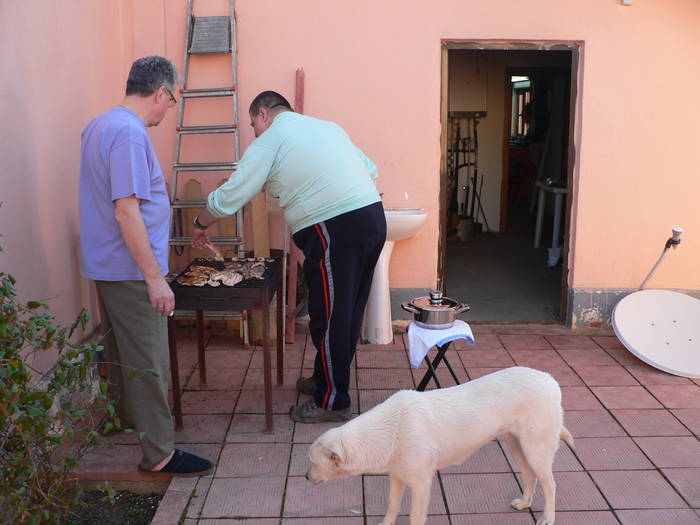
[441,474,521,514]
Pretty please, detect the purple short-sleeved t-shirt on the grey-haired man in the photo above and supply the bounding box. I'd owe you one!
[80,106,170,281]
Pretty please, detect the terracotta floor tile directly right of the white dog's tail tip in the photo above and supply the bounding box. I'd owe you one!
[576,437,654,470]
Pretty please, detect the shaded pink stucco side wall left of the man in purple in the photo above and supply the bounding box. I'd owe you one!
[0,0,132,348]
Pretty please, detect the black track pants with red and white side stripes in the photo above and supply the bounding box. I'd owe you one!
[294,202,386,410]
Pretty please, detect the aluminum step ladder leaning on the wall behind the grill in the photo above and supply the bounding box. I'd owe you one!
[170,0,245,257]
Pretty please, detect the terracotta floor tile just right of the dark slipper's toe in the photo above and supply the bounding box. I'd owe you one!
[214,443,292,478]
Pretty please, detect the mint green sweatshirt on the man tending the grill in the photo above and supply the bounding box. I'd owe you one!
[208,111,380,233]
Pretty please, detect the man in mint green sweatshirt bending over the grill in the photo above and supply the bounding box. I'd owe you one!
[192,91,386,423]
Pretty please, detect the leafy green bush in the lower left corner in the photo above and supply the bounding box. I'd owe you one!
[0,253,114,525]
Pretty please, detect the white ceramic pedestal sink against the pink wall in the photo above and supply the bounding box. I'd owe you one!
[361,208,428,345]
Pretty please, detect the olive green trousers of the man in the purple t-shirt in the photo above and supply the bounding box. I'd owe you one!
[95,281,175,469]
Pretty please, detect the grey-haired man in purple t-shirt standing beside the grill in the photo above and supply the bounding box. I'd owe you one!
[80,56,213,476]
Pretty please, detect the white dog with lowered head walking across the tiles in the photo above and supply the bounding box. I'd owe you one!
[306,367,573,525]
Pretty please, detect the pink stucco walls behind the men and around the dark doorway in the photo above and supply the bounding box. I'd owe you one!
[0,0,700,360]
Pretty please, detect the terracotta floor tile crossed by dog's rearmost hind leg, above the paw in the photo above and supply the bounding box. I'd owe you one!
[518,472,609,510]
